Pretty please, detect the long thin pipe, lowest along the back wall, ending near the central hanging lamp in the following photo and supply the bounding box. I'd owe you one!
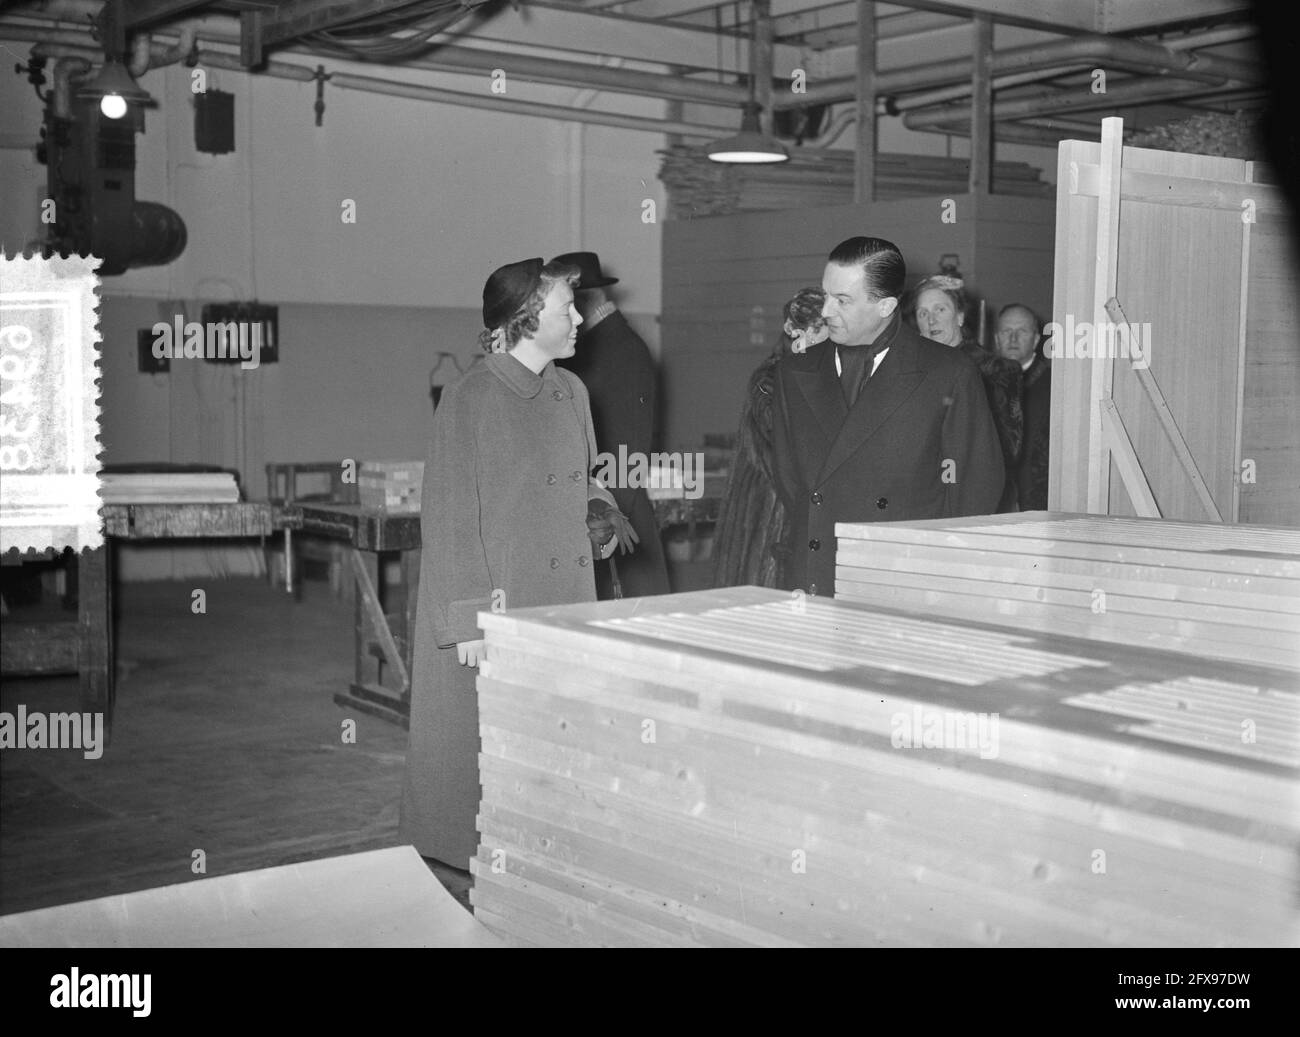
[31,43,719,139]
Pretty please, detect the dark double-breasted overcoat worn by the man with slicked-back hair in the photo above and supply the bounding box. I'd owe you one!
[772,313,1005,596]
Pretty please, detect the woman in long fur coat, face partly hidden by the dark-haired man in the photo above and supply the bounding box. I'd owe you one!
[714,288,827,587]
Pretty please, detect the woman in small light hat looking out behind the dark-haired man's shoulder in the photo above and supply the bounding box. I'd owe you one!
[913,274,1024,513]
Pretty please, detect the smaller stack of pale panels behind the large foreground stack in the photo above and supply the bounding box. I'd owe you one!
[835,512,1300,668]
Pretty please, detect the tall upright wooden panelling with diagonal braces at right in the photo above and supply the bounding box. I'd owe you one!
[1044,126,1300,525]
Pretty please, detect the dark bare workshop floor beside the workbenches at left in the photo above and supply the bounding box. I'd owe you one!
[0,550,709,914]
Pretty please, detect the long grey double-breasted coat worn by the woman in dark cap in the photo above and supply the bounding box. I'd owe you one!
[399,353,608,868]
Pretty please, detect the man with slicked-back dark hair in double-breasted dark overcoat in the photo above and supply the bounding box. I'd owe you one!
[772,237,1005,596]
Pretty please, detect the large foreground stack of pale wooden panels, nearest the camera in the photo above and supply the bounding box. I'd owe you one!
[471,587,1300,946]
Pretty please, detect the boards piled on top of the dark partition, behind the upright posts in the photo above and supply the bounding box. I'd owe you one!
[659,146,1054,220]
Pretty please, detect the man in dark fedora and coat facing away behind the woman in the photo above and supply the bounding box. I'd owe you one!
[553,252,668,599]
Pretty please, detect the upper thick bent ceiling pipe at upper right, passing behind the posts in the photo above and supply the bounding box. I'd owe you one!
[776,27,1264,108]
